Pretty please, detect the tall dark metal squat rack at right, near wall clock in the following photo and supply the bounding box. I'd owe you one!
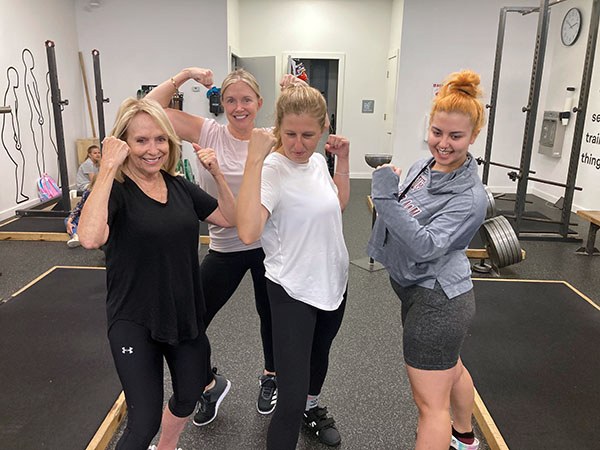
[481,0,600,241]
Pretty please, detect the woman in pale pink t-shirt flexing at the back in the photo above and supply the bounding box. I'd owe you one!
[147,67,277,426]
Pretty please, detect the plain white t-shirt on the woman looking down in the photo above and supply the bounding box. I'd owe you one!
[261,153,349,311]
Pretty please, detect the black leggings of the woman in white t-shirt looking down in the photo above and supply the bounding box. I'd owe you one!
[267,280,347,450]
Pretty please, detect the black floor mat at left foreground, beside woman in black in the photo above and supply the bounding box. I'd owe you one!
[0,267,121,450]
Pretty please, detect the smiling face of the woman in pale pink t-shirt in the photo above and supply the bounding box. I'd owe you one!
[221,81,262,139]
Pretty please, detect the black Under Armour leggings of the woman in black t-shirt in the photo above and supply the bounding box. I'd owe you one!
[108,320,208,450]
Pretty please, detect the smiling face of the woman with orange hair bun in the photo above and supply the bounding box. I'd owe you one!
[427,111,477,173]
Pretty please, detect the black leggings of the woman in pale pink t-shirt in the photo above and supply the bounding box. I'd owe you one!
[200,248,275,380]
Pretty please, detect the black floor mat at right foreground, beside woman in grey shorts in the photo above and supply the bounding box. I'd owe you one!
[462,279,600,450]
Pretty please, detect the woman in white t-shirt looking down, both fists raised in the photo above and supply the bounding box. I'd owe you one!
[237,83,350,450]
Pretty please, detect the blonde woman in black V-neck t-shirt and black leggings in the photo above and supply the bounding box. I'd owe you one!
[78,99,235,450]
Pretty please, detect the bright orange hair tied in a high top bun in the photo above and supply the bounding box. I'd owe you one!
[429,70,485,136]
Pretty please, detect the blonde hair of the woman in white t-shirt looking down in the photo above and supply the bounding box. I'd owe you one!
[273,85,327,148]
